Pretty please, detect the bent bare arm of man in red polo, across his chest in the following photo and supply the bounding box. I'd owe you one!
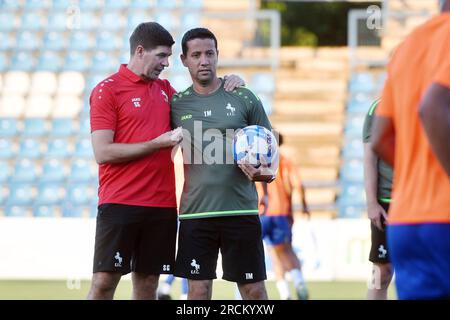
[91,130,181,164]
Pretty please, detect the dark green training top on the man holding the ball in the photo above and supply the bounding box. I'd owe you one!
[171,83,272,219]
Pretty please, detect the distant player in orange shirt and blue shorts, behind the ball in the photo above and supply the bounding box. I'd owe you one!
[257,134,310,300]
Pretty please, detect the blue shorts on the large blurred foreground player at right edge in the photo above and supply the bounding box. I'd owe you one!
[387,223,450,299]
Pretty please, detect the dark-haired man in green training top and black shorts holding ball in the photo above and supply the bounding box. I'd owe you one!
[171,28,274,300]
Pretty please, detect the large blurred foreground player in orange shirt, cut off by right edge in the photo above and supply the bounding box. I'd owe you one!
[372,0,450,299]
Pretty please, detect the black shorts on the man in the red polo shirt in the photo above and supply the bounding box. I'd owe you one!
[94,203,177,275]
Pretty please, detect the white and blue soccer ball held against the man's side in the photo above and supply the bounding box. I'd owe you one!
[233,125,278,174]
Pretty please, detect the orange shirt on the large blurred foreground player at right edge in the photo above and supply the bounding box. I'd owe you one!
[376,13,450,224]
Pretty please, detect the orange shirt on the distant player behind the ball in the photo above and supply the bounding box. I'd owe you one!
[257,152,300,216]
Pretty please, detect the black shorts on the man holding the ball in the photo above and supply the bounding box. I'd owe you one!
[174,215,267,283]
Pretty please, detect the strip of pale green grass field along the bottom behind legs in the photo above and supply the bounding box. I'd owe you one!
[0,279,396,300]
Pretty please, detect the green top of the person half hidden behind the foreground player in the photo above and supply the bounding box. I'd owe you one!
[363,99,393,202]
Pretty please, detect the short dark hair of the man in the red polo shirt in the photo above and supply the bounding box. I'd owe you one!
[130,22,175,55]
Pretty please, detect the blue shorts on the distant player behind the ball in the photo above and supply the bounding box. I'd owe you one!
[260,216,292,246]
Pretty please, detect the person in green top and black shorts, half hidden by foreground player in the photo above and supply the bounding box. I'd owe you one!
[363,100,393,300]
